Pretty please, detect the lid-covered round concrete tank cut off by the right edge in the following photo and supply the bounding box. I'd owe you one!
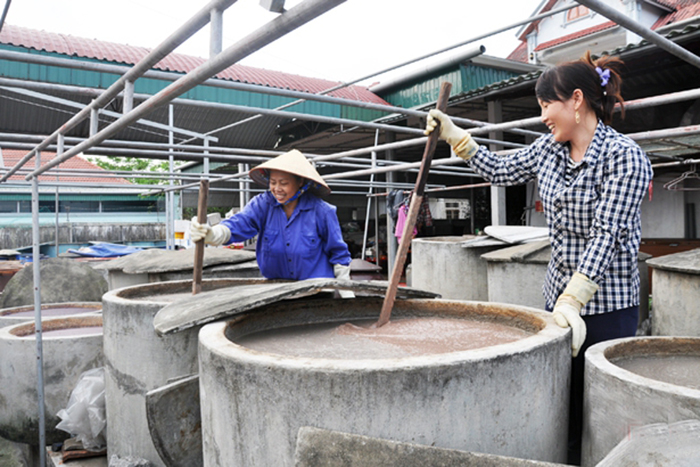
[647,248,700,337]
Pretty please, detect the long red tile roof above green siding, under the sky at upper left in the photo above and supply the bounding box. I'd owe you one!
[0,24,386,104]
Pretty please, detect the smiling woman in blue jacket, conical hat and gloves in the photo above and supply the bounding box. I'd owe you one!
[190,150,351,280]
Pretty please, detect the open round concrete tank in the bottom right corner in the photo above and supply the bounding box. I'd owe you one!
[581,337,700,466]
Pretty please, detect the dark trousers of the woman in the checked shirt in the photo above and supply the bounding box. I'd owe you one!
[569,306,639,465]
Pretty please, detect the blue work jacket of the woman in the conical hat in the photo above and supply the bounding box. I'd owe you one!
[221,191,351,280]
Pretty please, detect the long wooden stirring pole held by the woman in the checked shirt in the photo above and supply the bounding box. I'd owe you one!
[375,83,452,327]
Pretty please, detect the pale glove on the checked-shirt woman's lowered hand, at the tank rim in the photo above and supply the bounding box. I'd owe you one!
[552,272,598,357]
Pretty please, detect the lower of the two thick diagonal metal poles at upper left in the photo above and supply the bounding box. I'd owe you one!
[24,0,345,181]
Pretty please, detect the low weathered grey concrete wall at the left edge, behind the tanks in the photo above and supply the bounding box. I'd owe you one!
[0,223,165,249]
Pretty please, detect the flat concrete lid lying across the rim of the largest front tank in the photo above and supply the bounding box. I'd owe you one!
[153,278,440,335]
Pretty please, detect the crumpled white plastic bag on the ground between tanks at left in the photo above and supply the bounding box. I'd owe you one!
[56,367,107,450]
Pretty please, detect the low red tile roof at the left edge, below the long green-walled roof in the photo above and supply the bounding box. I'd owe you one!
[0,149,131,185]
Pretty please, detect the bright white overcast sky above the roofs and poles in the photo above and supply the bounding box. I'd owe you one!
[0,0,542,85]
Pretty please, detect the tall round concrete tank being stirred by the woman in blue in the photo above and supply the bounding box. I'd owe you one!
[102,279,265,465]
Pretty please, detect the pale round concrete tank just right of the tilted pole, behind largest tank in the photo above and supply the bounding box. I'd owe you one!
[411,235,503,301]
